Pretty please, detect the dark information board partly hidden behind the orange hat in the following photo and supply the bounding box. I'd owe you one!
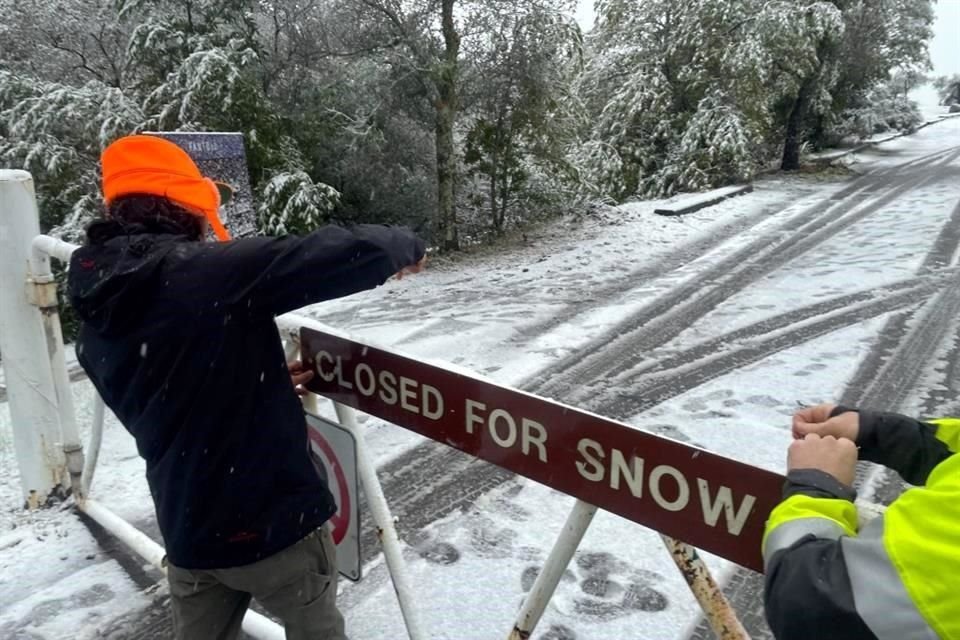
[146,131,257,238]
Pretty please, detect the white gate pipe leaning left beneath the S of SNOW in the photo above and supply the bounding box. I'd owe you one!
[509,500,597,640]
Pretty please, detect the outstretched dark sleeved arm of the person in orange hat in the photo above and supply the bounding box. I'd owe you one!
[189,225,425,315]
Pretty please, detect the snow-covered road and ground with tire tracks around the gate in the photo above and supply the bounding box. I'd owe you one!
[0,94,960,640]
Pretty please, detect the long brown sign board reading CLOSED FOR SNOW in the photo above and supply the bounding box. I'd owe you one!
[300,328,783,571]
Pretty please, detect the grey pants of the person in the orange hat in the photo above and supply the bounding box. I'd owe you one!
[167,527,347,640]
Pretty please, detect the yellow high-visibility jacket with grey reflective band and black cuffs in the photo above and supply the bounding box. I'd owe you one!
[763,407,960,640]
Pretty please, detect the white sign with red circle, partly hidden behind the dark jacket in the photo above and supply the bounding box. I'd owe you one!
[307,413,360,581]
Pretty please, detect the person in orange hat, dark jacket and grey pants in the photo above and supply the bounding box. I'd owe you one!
[68,136,425,640]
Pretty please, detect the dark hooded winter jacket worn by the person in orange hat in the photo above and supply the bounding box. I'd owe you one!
[69,222,424,569]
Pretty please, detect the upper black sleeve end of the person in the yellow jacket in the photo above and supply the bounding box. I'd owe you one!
[831,406,952,485]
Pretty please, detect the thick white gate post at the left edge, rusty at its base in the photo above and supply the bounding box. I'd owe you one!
[0,170,67,508]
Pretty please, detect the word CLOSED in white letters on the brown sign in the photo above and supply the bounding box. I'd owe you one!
[316,351,444,420]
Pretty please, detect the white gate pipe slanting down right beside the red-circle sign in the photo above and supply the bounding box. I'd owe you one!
[333,402,427,640]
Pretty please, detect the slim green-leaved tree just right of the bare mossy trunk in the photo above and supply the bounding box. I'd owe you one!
[464,0,582,233]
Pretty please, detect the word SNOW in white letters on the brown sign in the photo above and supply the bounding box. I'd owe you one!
[575,438,757,536]
